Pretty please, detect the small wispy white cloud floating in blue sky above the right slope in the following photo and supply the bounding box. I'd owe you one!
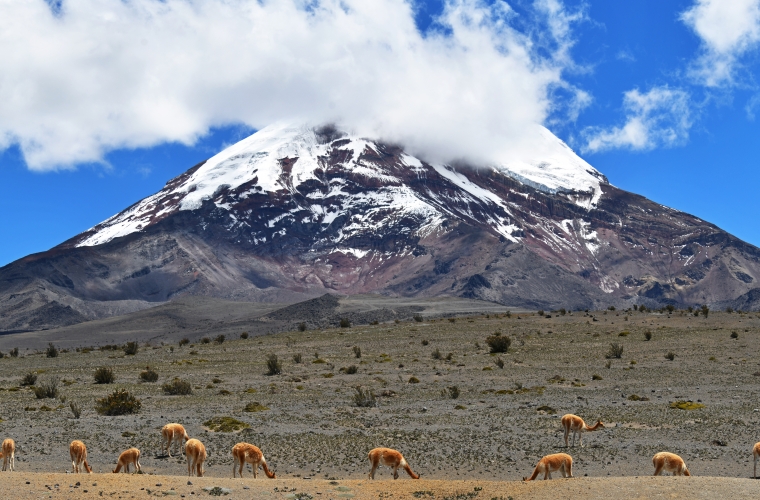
[582,86,692,153]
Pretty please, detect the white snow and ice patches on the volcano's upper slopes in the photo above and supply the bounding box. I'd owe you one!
[77,123,606,246]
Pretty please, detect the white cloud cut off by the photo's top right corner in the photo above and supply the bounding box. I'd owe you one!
[681,0,760,87]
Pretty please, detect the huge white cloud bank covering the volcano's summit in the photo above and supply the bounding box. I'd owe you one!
[0,0,588,170]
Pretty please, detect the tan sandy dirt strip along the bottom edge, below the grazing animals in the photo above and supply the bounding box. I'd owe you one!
[0,473,760,500]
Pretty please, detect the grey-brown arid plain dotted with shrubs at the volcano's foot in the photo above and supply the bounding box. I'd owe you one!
[0,302,760,498]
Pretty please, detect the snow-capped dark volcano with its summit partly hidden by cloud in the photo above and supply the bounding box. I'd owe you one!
[0,125,760,331]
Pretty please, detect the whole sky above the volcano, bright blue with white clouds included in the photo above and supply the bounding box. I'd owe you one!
[0,0,760,266]
